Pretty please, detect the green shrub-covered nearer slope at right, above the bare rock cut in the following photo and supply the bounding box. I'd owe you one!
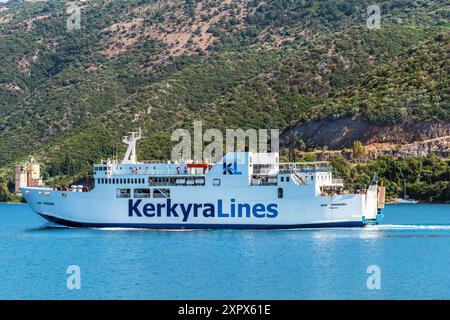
[316,32,450,124]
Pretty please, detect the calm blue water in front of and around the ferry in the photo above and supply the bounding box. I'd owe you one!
[0,204,450,299]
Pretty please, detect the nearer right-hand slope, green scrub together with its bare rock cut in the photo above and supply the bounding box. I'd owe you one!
[285,32,450,149]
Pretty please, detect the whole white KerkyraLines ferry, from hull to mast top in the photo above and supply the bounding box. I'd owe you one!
[21,132,385,229]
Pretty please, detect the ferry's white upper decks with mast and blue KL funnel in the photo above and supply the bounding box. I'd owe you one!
[88,131,343,195]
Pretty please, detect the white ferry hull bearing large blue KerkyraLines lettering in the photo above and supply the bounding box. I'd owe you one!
[23,181,384,229]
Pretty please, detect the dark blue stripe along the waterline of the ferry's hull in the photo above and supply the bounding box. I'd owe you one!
[39,213,365,229]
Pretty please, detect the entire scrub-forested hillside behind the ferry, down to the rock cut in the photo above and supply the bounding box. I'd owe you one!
[0,0,450,200]
